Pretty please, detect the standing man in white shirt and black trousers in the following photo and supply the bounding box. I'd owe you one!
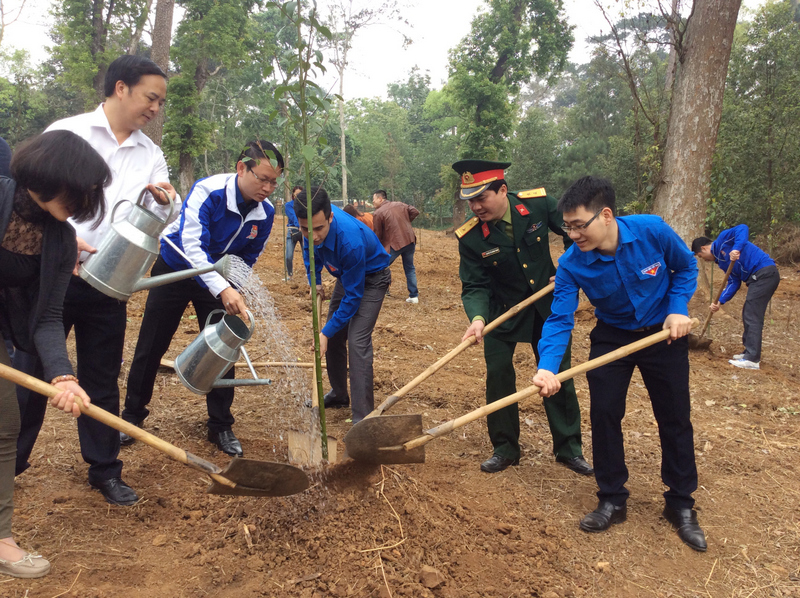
[15,56,180,505]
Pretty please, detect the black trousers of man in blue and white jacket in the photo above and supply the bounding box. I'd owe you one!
[122,256,235,432]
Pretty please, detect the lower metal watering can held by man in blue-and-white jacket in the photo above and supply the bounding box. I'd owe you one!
[175,309,272,395]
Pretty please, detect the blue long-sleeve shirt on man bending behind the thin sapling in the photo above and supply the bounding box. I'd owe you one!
[303,206,389,338]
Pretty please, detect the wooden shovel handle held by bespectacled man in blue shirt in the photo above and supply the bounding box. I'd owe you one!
[402,318,699,451]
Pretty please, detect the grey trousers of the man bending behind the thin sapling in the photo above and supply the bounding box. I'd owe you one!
[325,268,392,424]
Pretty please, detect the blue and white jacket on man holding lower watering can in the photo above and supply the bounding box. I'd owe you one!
[161,172,275,297]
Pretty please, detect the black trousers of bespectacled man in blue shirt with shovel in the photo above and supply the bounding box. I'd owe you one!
[586,321,697,509]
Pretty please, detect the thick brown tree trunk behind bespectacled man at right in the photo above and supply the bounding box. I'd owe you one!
[653,0,741,242]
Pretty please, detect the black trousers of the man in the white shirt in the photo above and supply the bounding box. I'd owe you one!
[14,276,127,482]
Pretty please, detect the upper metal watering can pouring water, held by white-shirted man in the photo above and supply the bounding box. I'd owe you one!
[80,187,229,301]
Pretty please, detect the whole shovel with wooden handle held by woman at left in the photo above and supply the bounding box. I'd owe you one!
[0,363,308,496]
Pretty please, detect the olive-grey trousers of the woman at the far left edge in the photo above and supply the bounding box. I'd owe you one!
[0,344,19,538]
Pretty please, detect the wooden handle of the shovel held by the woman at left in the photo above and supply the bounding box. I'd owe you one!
[0,363,236,487]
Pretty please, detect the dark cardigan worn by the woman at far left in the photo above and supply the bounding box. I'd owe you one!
[0,177,78,380]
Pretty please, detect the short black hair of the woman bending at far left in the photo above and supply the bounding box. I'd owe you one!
[11,131,111,225]
